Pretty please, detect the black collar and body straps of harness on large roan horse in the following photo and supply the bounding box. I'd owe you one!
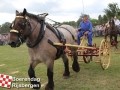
[27,20,75,59]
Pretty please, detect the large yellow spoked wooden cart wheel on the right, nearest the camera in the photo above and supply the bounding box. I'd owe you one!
[99,39,110,70]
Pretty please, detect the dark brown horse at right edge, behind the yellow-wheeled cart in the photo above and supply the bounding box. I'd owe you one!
[105,19,118,49]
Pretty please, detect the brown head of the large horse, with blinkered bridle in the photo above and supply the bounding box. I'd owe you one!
[9,9,31,47]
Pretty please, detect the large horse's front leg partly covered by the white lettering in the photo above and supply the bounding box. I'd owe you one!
[28,61,41,90]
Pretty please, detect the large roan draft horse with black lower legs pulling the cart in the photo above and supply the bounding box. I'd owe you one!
[9,9,80,90]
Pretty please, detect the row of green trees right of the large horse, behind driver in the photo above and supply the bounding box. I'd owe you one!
[63,3,120,27]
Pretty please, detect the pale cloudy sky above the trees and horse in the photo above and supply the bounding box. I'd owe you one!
[0,0,120,25]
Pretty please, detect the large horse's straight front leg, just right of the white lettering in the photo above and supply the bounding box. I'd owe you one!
[45,60,54,90]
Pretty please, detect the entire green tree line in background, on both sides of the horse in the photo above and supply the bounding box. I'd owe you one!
[0,3,120,33]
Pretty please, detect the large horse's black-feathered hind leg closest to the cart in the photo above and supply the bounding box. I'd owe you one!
[72,52,80,72]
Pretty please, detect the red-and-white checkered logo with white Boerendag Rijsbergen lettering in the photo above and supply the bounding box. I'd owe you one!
[0,74,40,89]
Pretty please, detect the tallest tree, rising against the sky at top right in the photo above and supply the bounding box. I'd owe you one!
[104,3,120,19]
